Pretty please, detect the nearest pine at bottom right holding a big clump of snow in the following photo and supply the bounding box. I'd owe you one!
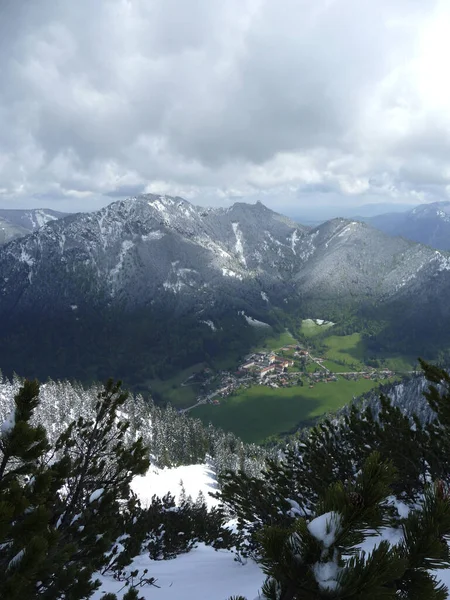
[232,452,450,600]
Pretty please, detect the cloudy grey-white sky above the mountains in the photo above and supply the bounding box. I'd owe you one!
[0,0,450,214]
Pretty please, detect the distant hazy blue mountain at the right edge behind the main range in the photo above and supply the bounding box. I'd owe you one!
[365,202,450,250]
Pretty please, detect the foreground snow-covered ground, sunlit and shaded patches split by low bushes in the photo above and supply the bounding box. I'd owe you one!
[93,465,265,600]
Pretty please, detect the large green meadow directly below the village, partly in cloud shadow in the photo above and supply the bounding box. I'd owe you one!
[191,379,384,443]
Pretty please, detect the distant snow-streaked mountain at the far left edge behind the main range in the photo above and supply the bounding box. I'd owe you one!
[0,208,67,244]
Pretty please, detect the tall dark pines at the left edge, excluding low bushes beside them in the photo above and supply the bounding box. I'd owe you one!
[0,381,149,600]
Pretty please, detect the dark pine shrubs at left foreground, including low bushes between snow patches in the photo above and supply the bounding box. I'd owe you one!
[0,381,239,600]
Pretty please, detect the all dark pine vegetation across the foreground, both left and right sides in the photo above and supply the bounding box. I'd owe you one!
[4,364,450,600]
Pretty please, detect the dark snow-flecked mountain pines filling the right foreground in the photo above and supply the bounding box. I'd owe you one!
[221,364,450,600]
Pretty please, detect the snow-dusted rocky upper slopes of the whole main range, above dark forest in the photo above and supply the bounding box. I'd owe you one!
[0,195,450,315]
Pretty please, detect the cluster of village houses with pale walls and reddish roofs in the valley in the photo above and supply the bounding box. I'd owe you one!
[183,343,394,412]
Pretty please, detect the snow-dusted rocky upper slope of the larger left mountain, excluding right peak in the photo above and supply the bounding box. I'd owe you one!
[0,195,306,318]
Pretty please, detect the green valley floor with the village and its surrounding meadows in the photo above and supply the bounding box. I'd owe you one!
[152,319,415,444]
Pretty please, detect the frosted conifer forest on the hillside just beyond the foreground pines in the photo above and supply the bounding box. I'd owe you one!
[0,377,267,474]
